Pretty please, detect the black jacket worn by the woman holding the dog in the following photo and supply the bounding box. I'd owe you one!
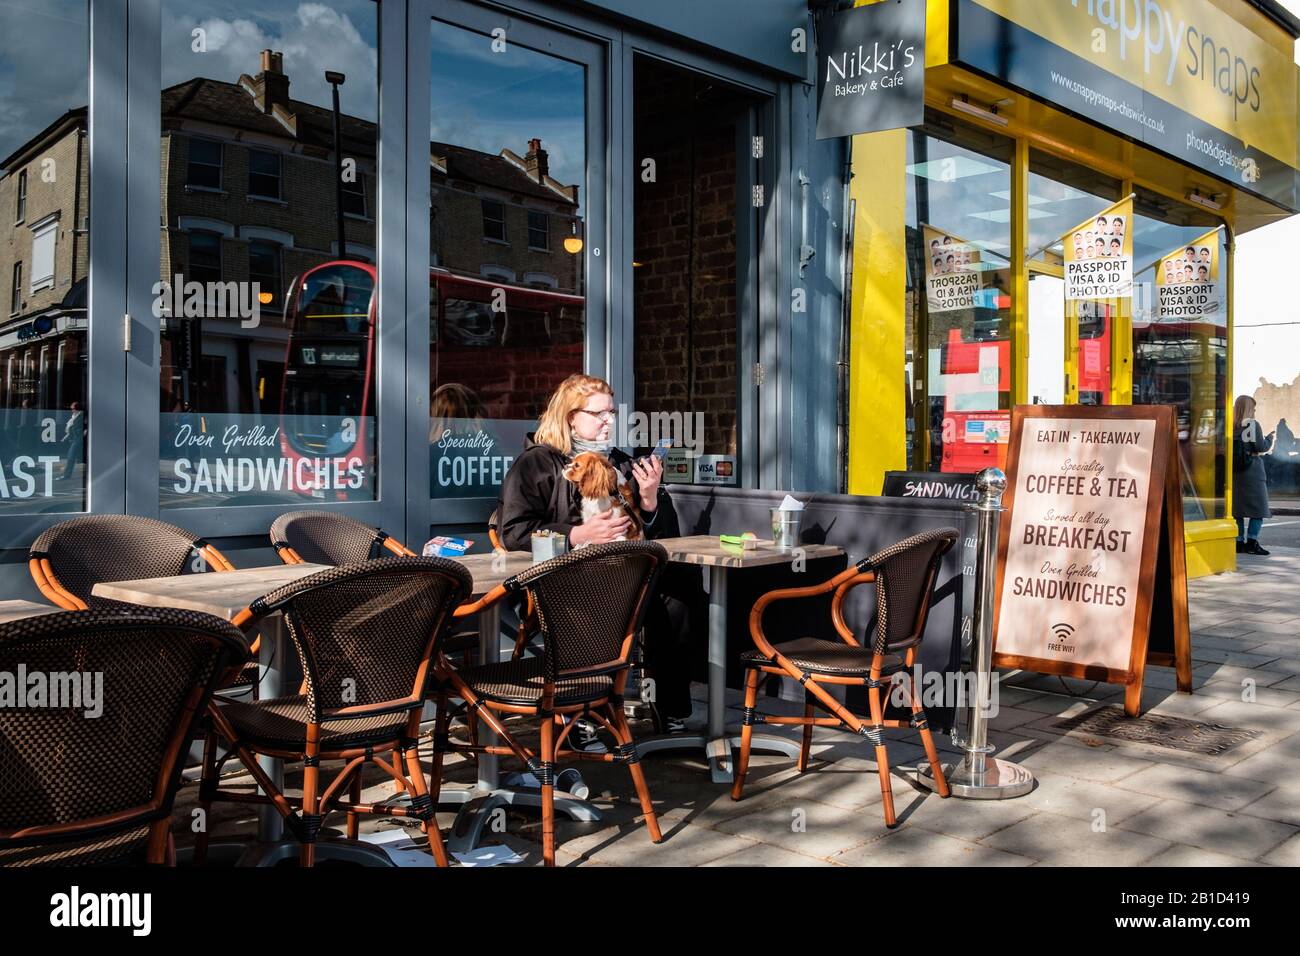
[497,436,680,551]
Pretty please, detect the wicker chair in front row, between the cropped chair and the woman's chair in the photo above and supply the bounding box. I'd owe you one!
[195,558,472,866]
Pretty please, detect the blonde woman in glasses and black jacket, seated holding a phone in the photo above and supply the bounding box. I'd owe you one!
[498,375,690,749]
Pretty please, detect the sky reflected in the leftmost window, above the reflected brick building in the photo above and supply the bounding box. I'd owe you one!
[0,0,90,170]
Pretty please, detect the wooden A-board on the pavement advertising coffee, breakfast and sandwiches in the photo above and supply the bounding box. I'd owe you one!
[993,405,1192,717]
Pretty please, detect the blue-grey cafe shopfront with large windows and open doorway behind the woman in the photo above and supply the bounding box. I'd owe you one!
[0,0,845,597]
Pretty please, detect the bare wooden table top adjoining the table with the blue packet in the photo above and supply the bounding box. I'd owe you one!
[91,564,329,620]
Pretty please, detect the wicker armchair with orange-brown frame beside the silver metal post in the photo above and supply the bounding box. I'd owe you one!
[732,528,958,827]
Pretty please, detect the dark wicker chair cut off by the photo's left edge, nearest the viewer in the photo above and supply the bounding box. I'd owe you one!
[0,607,248,866]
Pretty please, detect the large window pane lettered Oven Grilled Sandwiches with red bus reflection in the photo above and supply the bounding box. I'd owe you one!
[126,0,406,536]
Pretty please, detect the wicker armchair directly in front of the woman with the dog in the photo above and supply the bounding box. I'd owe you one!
[429,541,668,866]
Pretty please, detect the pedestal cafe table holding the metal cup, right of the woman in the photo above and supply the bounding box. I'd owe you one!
[637,535,844,783]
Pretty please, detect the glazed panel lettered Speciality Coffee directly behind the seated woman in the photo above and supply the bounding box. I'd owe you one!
[407,3,605,533]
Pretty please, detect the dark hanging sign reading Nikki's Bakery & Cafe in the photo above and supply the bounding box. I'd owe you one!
[816,0,926,139]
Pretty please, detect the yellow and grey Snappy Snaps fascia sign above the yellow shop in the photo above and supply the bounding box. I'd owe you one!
[949,0,1297,211]
